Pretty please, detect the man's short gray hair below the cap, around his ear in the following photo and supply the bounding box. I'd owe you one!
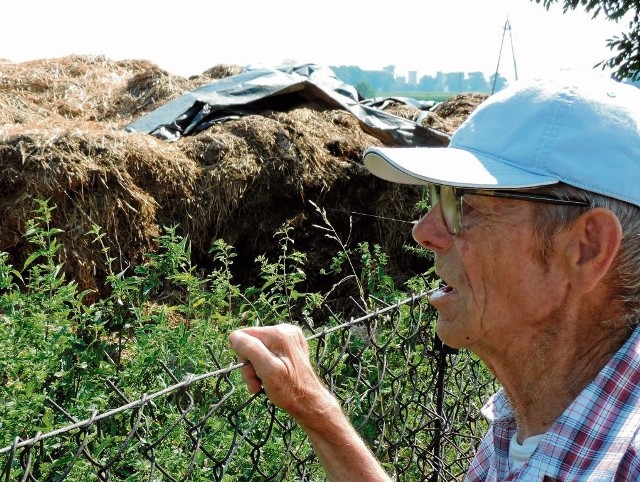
[534,184,640,326]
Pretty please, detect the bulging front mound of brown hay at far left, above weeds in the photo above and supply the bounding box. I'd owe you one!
[0,118,199,296]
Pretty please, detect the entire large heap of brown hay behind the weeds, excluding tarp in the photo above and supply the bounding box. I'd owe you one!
[0,56,486,295]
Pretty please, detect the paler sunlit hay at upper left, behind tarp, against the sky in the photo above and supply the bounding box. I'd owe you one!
[0,55,241,128]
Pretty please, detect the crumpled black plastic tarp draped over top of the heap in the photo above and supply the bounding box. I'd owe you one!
[126,64,450,147]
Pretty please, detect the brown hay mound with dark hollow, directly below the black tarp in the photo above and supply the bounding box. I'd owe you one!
[179,104,424,284]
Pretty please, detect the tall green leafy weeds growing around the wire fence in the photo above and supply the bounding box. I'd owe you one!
[0,201,495,481]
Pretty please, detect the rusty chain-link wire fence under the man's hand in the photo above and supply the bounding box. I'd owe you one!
[0,293,497,482]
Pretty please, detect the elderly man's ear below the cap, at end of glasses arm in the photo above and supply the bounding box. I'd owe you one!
[570,208,622,292]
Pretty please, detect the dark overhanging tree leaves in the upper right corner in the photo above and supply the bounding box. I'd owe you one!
[534,0,640,80]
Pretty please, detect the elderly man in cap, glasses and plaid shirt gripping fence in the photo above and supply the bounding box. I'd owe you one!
[230,76,640,482]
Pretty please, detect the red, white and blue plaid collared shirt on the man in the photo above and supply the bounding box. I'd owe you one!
[465,327,640,482]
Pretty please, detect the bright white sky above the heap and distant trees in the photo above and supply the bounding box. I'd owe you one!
[0,0,626,81]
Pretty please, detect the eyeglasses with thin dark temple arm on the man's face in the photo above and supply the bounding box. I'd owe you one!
[427,183,589,235]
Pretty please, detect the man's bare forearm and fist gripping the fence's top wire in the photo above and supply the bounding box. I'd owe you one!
[229,324,389,482]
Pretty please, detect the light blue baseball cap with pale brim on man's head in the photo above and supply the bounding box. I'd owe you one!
[363,74,640,206]
